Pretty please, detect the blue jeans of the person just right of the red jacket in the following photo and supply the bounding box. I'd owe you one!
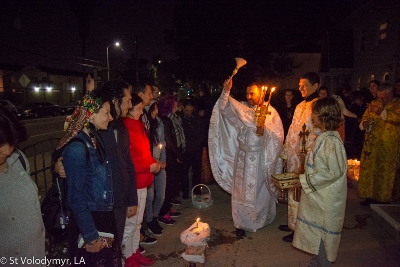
[146,169,167,222]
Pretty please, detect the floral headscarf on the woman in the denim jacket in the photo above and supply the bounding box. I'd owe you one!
[57,92,103,149]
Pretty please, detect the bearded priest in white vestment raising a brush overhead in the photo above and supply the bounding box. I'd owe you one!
[208,79,283,236]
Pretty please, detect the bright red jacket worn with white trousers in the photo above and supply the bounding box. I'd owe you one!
[124,118,156,189]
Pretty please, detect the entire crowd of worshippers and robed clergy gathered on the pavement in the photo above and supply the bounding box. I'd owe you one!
[0,72,400,267]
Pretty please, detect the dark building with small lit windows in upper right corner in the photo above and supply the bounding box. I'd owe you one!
[347,0,400,88]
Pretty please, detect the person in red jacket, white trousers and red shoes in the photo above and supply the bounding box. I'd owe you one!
[122,94,160,267]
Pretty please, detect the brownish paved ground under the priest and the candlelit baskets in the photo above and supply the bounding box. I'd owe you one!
[141,184,400,267]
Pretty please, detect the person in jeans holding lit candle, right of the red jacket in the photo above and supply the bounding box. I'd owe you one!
[145,100,167,236]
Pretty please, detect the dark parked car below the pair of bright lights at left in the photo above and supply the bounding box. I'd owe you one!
[19,101,61,118]
